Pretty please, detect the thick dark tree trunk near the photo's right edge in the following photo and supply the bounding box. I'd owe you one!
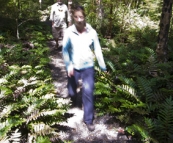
[156,0,173,62]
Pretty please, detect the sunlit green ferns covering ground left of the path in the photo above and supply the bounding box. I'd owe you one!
[0,21,68,143]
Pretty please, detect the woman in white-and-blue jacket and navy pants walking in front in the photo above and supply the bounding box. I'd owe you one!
[62,6,106,131]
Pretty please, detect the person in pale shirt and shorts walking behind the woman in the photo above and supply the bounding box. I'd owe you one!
[50,0,71,48]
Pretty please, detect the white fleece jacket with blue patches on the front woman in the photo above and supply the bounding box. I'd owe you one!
[62,24,106,71]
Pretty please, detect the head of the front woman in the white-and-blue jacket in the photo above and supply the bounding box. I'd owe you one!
[72,6,86,27]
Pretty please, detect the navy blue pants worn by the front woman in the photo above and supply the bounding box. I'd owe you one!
[68,67,94,124]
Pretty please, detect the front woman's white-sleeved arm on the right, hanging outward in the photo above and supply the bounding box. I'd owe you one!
[94,32,106,71]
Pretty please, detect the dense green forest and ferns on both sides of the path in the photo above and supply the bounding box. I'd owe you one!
[0,0,173,143]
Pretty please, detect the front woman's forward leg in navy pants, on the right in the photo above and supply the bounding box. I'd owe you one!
[82,68,94,124]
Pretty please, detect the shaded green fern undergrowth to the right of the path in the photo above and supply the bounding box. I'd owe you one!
[95,13,173,143]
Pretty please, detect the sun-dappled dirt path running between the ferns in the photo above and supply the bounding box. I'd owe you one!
[48,40,128,143]
